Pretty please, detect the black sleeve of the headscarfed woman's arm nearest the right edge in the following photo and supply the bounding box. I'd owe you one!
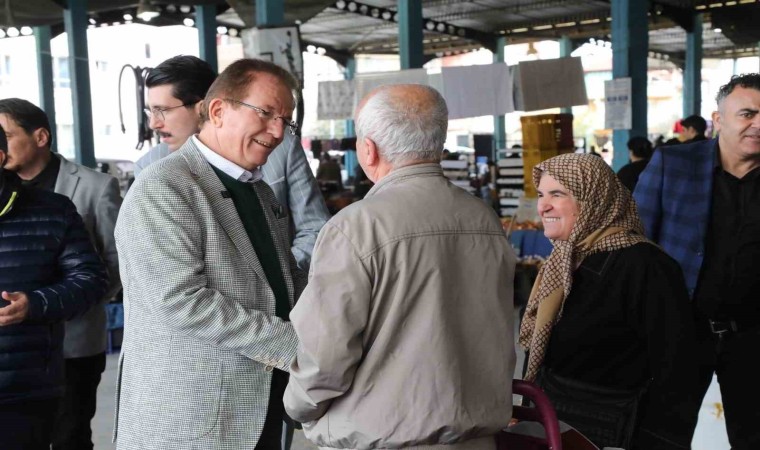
[634,253,702,450]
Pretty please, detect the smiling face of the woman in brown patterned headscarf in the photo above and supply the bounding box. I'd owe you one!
[538,173,580,241]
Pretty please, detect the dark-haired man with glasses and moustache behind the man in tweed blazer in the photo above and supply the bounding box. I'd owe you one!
[135,55,330,272]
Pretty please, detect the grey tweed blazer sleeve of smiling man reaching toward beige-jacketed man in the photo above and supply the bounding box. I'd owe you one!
[116,175,297,370]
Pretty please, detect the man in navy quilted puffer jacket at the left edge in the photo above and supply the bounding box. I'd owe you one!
[0,124,108,450]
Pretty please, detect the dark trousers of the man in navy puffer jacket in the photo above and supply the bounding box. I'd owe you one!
[0,398,58,450]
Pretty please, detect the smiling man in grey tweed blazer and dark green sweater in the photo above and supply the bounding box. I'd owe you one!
[115,59,306,450]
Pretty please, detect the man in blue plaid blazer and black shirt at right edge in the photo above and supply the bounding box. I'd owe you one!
[634,73,760,450]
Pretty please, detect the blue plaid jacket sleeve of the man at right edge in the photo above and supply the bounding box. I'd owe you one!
[633,149,665,242]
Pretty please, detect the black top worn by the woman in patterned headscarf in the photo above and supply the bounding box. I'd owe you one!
[544,243,702,448]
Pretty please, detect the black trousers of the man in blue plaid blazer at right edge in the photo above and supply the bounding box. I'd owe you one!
[696,319,760,450]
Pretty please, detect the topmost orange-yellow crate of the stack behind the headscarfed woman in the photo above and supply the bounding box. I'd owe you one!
[520,114,574,150]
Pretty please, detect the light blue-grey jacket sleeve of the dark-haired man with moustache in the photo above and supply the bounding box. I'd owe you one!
[285,137,330,272]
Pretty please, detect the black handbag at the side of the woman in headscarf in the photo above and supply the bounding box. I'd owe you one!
[536,370,647,449]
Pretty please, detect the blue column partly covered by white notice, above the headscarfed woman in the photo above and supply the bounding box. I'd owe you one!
[612,0,649,171]
